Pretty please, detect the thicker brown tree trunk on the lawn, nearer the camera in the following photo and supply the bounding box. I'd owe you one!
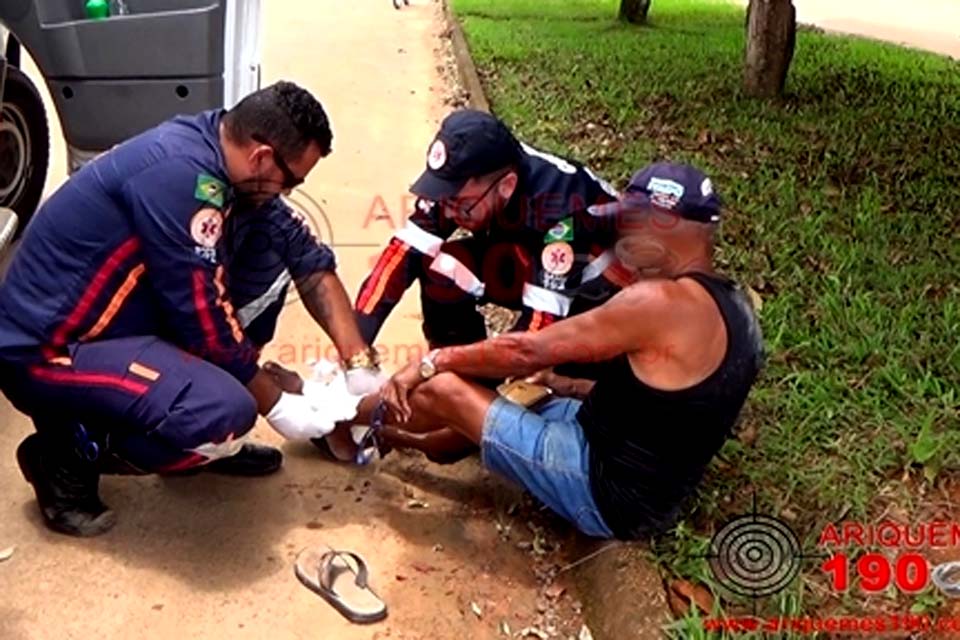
[743,0,797,98]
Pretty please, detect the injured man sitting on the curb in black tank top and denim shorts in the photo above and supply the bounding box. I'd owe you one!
[372,164,763,539]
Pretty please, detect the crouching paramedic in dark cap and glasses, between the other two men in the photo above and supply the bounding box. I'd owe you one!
[356,109,616,348]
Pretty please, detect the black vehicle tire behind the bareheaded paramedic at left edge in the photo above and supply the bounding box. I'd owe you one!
[0,63,50,237]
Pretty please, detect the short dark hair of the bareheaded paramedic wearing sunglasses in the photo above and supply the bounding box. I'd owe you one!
[223,81,333,158]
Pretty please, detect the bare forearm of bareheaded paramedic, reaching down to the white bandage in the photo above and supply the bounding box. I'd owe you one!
[297,271,367,360]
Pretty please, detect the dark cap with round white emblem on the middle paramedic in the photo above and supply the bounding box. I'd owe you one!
[410,109,522,202]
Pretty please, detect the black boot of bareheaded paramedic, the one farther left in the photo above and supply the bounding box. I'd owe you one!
[17,433,117,537]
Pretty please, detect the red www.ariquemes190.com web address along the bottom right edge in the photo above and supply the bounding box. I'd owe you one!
[703,613,960,637]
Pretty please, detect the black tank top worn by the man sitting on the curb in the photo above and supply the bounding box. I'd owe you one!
[577,273,763,539]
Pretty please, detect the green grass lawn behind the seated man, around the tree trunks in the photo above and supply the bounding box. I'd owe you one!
[453,0,960,632]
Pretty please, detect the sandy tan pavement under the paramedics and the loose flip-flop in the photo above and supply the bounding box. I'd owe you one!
[0,0,579,640]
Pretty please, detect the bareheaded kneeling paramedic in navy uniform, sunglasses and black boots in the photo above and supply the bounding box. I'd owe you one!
[0,82,379,536]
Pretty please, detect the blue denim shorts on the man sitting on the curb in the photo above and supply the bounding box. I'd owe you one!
[481,397,613,538]
